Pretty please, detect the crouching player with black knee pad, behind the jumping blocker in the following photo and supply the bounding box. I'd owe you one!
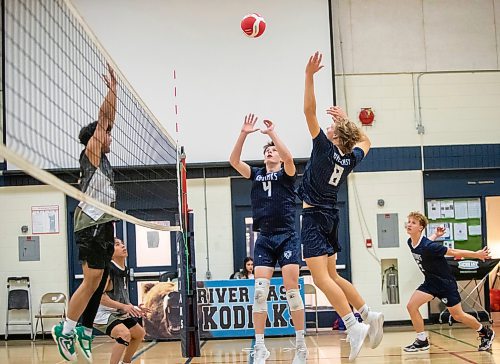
[94,238,149,364]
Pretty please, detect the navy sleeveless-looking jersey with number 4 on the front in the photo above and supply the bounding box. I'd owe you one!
[250,167,296,232]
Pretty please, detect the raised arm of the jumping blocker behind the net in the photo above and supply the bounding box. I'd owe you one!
[86,64,116,166]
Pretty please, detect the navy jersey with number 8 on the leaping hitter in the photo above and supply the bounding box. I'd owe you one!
[297,129,365,209]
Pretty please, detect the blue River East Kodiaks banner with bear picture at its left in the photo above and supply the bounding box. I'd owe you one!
[141,277,304,340]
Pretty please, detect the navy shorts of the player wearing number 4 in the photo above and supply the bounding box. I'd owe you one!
[253,231,301,268]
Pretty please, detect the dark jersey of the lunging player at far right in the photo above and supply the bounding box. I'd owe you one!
[408,235,455,282]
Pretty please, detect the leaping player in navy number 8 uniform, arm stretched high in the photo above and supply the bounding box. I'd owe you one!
[298,52,384,360]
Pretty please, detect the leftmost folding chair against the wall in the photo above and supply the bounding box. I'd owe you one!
[5,277,33,340]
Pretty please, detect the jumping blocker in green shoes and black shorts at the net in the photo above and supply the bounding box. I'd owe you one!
[52,64,117,362]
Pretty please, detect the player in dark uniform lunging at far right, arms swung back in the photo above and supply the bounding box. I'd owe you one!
[404,212,495,352]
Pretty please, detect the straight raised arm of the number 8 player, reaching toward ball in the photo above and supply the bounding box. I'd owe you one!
[304,52,323,139]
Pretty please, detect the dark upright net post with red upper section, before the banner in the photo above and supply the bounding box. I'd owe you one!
[176,147,201,358]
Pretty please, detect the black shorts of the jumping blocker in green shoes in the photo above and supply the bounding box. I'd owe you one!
[75,222,115,269]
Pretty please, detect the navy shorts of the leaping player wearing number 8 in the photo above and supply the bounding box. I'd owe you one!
[300,207,341,259]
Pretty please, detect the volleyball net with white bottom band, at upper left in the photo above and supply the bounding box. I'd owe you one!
[0,0,181,231]
